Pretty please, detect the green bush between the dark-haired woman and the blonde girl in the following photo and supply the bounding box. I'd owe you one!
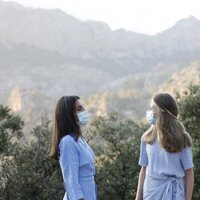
[91,113,144,200]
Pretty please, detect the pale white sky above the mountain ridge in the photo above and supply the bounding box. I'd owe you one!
[4,0,200,34]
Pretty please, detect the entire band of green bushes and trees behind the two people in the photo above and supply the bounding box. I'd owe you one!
[0,84,200,200]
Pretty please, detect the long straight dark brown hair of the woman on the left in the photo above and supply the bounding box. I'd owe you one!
[49,96,82,160]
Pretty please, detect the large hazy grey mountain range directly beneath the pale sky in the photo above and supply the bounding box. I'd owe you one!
[0,0,200,123]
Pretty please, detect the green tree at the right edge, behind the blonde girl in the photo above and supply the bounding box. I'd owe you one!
[177,84,200,200]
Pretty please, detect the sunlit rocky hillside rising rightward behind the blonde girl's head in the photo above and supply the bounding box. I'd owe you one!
[84,62,200,122]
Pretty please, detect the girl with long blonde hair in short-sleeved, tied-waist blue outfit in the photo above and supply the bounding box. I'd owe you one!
[136,94,194,200]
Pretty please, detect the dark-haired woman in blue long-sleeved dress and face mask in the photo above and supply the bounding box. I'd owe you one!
[50,96,97,200]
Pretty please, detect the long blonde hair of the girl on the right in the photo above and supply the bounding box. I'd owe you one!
[142,93,192,153]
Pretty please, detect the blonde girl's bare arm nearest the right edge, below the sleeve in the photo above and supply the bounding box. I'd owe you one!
[185,168,194,200]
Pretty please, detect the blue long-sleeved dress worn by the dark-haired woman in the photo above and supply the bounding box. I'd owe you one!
[59,134,97,200]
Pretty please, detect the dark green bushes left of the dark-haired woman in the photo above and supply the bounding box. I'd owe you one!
[0,107,64,200]
